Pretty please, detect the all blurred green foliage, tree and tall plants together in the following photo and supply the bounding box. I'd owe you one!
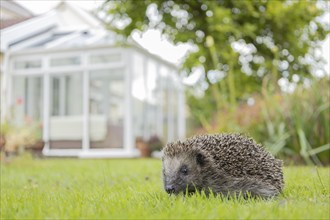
[103,0,330,164]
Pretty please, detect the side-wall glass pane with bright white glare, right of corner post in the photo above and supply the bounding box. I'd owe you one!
[132,53,163,146]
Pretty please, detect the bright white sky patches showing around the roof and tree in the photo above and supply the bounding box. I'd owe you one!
[16,0,330,75]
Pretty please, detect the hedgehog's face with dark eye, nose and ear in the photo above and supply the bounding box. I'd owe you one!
[163,154,203,195]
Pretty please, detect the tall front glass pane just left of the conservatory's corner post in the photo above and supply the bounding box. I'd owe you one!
[89,69,125,148]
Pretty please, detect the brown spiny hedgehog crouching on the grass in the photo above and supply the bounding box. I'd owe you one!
[162,134,284,199]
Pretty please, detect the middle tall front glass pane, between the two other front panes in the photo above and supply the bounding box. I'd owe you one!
[49,72,83,149]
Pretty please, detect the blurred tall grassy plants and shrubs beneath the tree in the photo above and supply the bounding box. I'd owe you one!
[204,78,330,165]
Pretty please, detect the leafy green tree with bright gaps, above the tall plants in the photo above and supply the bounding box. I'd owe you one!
[102,0,329,124]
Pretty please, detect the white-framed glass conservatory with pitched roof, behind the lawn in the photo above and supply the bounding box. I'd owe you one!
[2,3,185,157]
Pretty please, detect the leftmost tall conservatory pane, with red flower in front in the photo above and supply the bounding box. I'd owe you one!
[13,76,43,140]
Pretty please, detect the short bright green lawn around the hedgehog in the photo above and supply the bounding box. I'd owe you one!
[1,157,330,219]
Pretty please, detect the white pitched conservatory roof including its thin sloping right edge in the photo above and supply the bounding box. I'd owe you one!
[0,2,178,68]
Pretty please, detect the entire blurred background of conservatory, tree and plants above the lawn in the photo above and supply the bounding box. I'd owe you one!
[0,0,330,165]
